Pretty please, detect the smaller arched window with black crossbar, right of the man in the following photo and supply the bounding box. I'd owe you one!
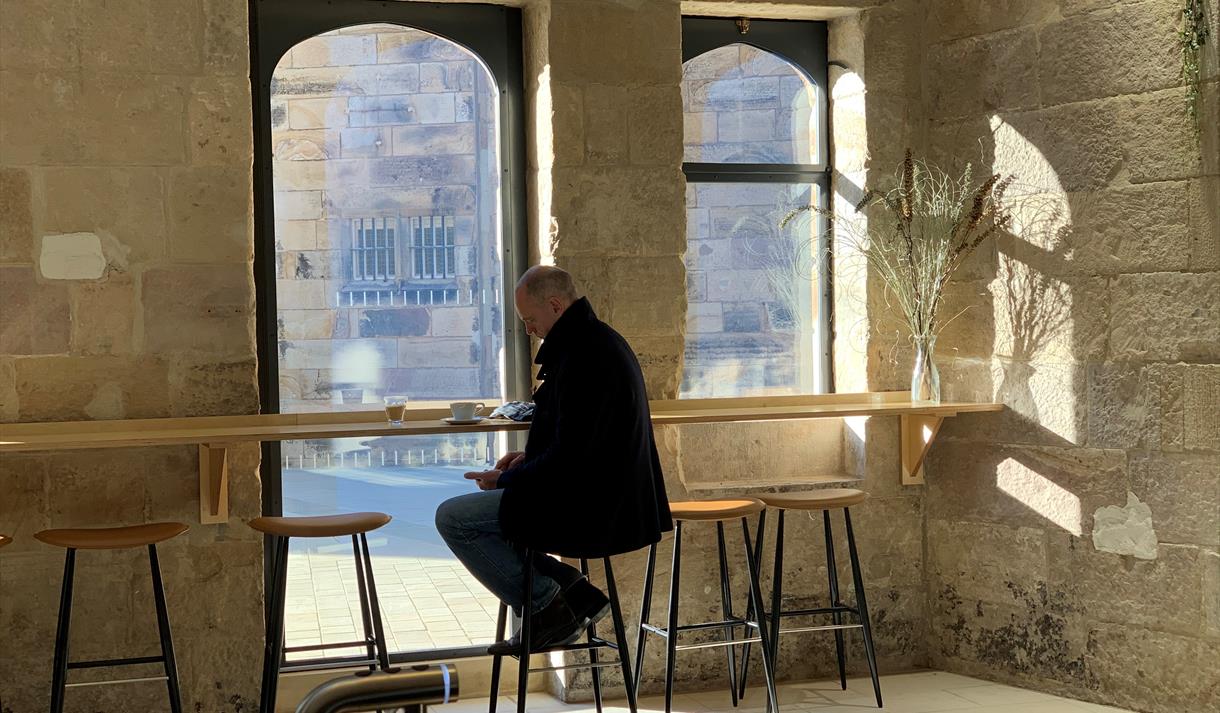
[681,18,831,398]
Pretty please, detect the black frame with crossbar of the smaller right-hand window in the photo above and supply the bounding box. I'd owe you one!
[682,16,834,393]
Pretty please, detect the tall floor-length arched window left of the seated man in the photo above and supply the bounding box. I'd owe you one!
[253,0,529,665]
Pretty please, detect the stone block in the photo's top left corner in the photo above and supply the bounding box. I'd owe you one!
[0,0,82,71]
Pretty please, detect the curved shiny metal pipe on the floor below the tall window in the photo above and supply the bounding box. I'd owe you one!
[296,663,458,713]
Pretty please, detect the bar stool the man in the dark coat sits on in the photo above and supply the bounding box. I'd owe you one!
[488,548,637,713]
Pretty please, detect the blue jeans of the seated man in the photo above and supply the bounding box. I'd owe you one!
[437,490,583,615]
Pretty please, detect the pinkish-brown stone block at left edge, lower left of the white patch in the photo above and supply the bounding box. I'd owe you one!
[0,266,72,357]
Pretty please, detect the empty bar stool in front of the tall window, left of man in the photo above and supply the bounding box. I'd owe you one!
[249,513,390,713]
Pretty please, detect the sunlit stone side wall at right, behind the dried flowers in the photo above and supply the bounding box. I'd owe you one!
[921,0,1220,712]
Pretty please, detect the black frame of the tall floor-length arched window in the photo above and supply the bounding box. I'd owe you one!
[249,0,529,663]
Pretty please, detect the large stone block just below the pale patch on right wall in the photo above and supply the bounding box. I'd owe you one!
[1049,537,1203,635]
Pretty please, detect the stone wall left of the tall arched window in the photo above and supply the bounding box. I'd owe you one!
[0,0,262,713]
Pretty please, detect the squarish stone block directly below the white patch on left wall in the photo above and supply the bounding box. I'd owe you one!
[71,275,138,354]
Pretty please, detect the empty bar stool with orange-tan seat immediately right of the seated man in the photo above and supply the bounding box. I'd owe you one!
[636,497,778,713]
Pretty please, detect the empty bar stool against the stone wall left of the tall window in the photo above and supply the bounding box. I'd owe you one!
[34,523,187,713]
